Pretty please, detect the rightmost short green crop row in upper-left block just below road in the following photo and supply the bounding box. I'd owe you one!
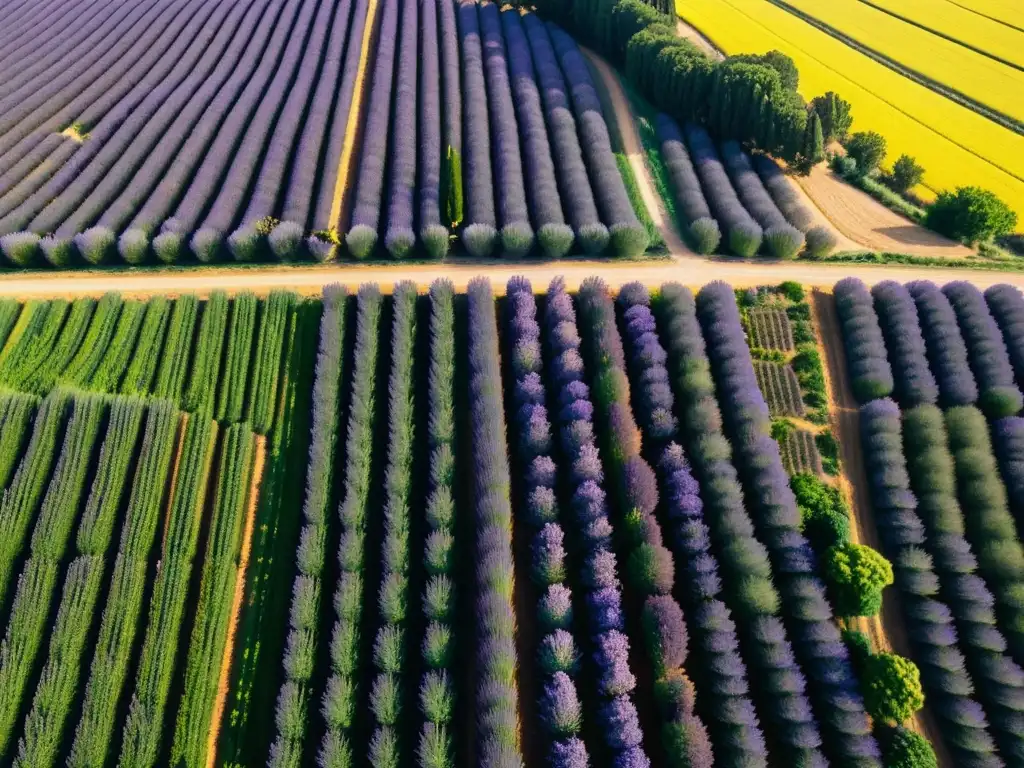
[246,291,298,435]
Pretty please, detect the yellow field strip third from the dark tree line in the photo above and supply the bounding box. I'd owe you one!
[865,0,1024,67]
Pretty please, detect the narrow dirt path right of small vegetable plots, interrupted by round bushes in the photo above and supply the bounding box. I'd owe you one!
[812,291,954,768]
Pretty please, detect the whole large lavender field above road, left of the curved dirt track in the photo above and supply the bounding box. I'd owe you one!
[0,0,648,267]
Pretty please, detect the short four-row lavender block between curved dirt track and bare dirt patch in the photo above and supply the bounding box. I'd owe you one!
[655,114,836,259]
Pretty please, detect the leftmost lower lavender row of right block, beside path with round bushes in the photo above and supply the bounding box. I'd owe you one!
[860,398,1004,768]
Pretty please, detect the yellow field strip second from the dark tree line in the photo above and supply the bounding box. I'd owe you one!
[786,0,1024,120]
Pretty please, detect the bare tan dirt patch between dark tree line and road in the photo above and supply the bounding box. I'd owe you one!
[798,165,973,258]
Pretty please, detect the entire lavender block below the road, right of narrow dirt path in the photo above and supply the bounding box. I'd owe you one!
[836,279,1024,766]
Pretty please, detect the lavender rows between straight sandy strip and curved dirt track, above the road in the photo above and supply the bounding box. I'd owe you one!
[345,0,647,259]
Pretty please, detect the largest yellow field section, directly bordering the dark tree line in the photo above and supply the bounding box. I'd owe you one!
[676,0,1024,228]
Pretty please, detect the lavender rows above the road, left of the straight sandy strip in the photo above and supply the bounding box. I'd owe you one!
[0,0,369,266]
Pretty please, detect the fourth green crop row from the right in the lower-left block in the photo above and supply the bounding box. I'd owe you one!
[14,399,145,768]
